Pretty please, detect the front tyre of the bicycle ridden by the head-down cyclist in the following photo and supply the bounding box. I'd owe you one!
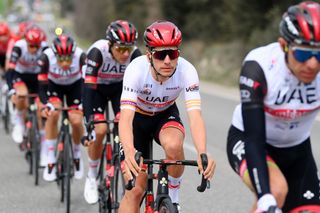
[63,133,72,213]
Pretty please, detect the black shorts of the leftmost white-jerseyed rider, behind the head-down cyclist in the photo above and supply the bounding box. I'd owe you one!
[12,71,39,94]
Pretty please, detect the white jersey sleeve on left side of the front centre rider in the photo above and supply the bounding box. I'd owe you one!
[120,61,140,111]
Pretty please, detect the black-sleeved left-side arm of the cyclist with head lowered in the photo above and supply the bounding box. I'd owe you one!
[37,53,49,104]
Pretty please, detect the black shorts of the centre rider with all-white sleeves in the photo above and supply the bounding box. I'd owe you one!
[133,104,183,159]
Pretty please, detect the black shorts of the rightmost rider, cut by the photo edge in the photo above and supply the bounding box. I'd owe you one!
[227,126,320,212]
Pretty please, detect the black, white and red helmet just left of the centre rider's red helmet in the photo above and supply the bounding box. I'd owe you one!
[106,20,138,45]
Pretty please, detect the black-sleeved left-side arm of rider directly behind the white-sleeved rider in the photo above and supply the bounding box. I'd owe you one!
[83,47,103,121]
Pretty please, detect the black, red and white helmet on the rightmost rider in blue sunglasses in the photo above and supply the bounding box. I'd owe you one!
[280,1,320,46]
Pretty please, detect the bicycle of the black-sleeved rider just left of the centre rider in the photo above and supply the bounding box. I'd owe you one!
[83,105,125,213]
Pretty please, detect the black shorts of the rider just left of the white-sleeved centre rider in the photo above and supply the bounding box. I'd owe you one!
[92,82,122,118]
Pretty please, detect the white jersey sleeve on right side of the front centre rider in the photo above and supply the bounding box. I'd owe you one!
[183,60,201,111]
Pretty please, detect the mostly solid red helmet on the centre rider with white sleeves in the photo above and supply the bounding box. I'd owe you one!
[143,21,182,49]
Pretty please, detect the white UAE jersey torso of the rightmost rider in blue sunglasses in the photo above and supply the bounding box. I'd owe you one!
[232,43,320,147]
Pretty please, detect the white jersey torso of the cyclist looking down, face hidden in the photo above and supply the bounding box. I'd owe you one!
[43,47,83,85]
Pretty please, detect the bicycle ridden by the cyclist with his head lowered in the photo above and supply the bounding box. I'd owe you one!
[50,107,79,213]
